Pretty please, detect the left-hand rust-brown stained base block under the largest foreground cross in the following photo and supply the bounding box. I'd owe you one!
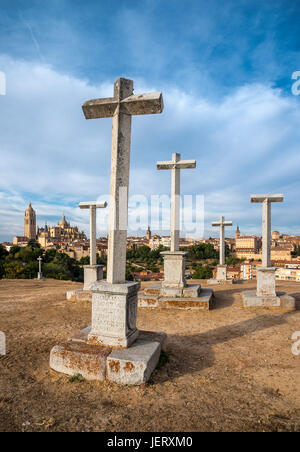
[50,342,111,381]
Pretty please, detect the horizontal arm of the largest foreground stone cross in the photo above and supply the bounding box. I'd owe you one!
[82,93,164,119]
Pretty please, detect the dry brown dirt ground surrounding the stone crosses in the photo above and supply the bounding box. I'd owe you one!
[0,280,300,432]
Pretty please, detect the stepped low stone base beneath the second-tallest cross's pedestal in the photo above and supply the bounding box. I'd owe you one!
[138,283,213,310]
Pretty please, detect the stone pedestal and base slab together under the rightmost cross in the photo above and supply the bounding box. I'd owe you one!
[242,267,297,310]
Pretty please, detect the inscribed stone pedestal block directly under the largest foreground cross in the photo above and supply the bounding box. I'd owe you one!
[88,281,140,347]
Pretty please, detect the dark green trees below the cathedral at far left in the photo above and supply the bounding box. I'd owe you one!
[0,240,83,281]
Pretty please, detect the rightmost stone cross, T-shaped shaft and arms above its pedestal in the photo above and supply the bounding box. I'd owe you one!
[250,194,283,268]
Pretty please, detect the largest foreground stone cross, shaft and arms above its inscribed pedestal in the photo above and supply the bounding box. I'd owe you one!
[82,78,163,284]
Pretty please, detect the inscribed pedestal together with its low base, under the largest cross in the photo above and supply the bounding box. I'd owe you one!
[50,281,166,385]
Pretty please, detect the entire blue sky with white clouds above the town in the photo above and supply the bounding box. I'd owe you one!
[0,0,300,241]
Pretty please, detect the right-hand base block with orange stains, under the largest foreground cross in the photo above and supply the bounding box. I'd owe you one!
[106,339,161,385]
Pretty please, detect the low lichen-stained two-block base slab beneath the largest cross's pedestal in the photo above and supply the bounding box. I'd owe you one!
[50,327,167,385]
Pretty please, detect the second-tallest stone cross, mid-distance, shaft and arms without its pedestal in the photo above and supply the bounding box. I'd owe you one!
[156,154,196,252]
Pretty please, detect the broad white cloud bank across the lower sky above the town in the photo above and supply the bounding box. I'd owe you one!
[0,56,300,240]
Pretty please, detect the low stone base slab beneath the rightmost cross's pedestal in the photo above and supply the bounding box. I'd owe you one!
[242,290,297,311]
